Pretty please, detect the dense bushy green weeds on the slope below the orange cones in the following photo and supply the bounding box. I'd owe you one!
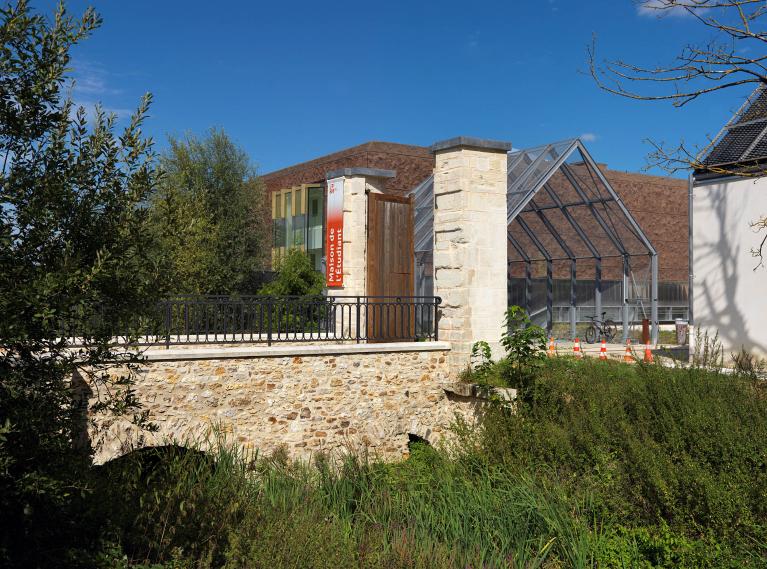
[479,359,767,555]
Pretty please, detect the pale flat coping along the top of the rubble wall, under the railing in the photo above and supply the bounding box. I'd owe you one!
[143,342,450,362]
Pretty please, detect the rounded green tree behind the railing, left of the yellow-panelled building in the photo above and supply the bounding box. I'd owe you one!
[149,129,270,294]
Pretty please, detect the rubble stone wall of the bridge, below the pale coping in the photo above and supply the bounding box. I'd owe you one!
[91,349,480,462]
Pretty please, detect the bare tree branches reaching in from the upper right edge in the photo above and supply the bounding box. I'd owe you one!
[586,0,767,269]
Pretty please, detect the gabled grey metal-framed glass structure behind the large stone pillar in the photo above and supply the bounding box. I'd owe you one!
[411,138,658,343]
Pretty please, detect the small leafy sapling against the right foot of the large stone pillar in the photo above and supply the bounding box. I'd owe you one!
[501,306,546,387]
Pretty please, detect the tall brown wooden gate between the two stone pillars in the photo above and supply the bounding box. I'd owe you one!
[365,194,415,342]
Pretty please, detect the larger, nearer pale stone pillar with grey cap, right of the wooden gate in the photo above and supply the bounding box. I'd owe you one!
[431,136,511,373]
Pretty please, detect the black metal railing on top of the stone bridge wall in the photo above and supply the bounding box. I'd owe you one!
[131,296,441,346]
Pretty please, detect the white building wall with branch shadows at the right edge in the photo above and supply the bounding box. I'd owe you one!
[690,178,767,358]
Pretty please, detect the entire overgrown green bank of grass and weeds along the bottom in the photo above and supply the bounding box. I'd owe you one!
[22,358,767,568]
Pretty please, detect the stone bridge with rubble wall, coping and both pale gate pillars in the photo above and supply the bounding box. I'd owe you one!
[91,137,511,461]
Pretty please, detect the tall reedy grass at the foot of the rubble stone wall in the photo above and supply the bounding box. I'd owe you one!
[93,432,589,567]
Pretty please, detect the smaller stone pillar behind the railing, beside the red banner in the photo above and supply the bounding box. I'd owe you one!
[326,168,397,335]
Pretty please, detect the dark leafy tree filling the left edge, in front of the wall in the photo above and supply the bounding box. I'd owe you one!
[0,1,161,567]
